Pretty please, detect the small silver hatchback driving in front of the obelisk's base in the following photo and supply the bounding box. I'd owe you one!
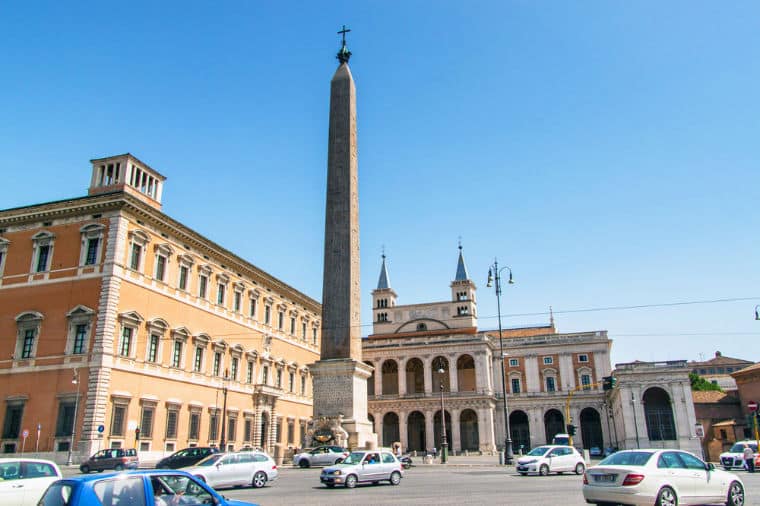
[319,450,404,488]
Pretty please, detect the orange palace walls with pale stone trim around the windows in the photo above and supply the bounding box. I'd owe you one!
[0,180,320,460]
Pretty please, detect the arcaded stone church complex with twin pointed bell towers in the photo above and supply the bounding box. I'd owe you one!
[363,253,698,454]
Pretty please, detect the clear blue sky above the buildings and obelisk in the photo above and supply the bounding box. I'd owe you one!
[0,0,760,362]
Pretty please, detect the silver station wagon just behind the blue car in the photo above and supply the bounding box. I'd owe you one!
[183,451,278,488]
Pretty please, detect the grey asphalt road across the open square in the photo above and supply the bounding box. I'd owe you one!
[209,465,760,506]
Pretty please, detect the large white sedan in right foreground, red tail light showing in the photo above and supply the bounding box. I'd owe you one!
[583,450,744,506]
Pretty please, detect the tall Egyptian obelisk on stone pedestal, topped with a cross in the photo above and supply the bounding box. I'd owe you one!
[310,26,377,448]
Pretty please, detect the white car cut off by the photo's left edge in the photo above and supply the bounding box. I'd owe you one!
[0,458,63,506]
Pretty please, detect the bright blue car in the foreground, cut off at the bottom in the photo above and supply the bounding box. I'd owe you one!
[38,469,255,506]
